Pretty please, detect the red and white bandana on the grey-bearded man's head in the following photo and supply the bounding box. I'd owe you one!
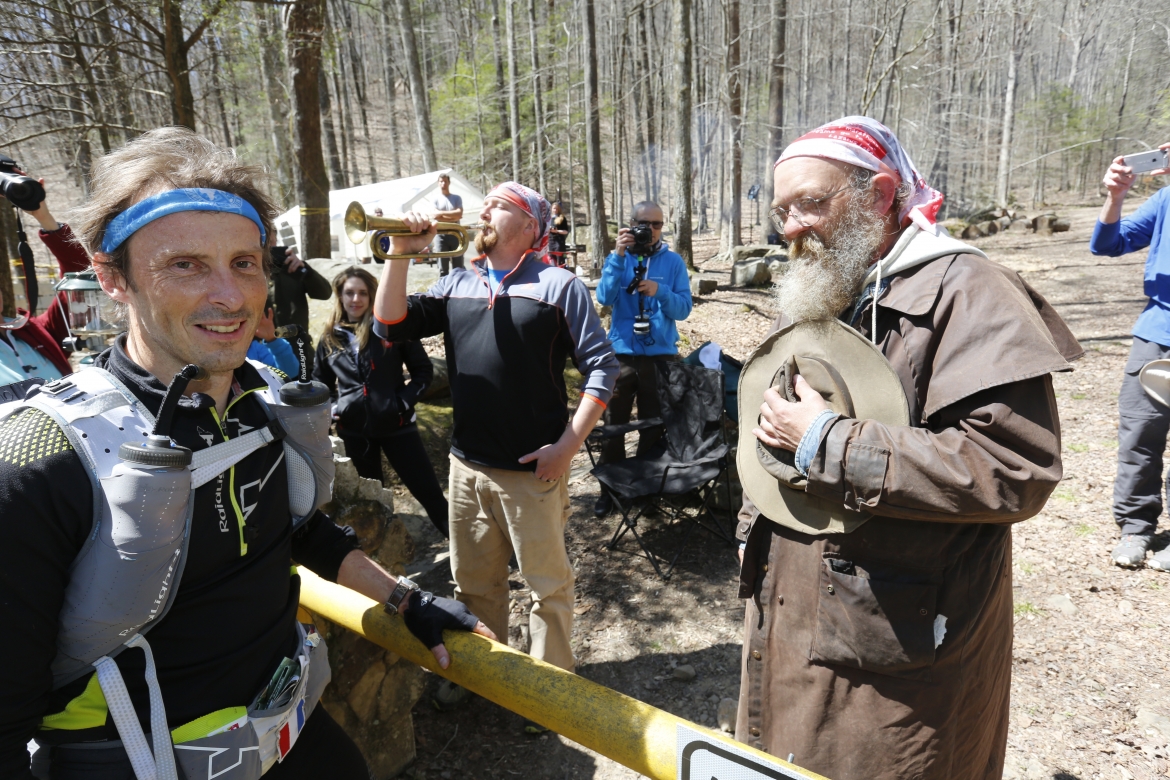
[776,117,943,230]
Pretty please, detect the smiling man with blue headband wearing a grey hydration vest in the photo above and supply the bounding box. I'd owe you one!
[0,127,491,780]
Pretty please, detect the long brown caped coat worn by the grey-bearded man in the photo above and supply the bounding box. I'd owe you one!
[736,255,1082,780]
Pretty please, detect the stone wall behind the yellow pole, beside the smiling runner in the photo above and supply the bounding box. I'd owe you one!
[304,440,425,780]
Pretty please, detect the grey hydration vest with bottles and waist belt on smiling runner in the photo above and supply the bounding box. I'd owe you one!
[0,361,333,780]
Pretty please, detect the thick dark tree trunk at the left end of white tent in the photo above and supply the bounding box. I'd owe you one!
[284,0,331,258]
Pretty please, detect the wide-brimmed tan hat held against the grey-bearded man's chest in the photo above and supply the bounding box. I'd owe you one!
[736,319,910,534]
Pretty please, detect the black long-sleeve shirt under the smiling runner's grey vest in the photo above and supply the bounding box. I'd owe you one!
[0,339,357,778]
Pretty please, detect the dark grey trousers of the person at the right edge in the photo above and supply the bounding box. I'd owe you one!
[1113,336,1170,536]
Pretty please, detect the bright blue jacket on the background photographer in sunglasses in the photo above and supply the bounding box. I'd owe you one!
[597,241,693,354]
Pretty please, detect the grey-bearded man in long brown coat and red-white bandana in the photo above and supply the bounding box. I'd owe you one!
[736,117,1081,780]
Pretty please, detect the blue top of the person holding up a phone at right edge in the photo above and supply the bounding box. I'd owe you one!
[1089,187,1170,346]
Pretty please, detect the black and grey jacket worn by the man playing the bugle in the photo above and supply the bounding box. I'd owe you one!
[373,254,618,471]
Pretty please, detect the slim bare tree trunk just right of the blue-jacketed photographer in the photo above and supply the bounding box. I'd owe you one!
[672,0,687,270]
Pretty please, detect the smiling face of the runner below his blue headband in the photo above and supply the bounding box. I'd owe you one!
[102,212,268,375]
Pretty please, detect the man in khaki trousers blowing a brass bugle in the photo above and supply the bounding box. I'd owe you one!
[373,181,618,733]
